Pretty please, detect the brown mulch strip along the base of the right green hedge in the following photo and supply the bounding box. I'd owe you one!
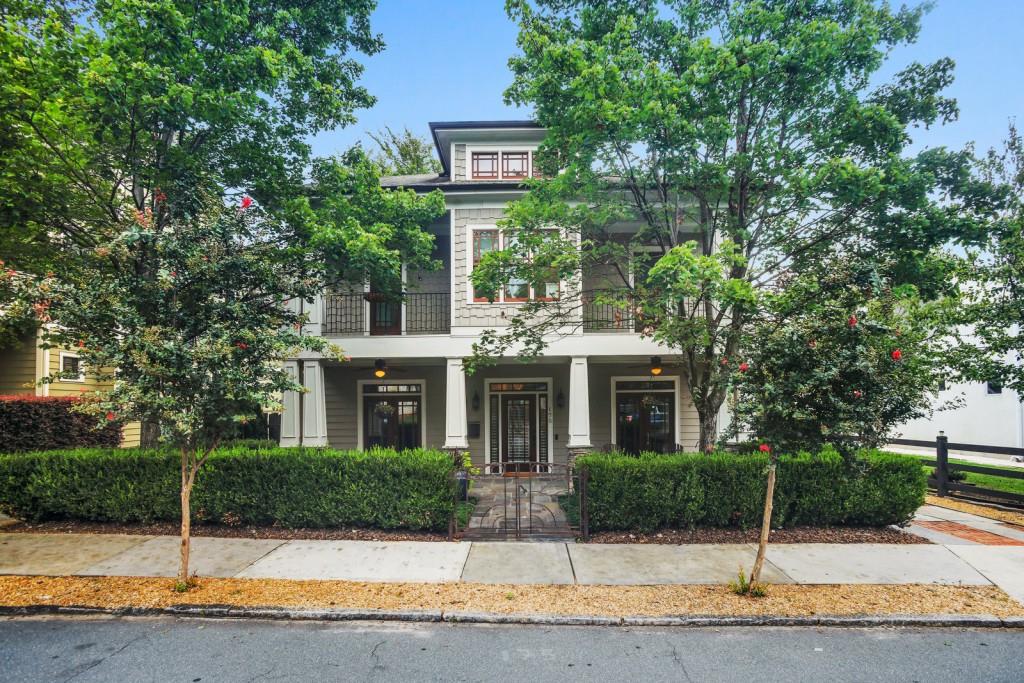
[590,526,932,545]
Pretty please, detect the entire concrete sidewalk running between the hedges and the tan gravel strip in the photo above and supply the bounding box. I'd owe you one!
[0,506,1024,602]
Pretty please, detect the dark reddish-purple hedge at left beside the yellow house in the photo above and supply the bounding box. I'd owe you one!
[0,396,121,453]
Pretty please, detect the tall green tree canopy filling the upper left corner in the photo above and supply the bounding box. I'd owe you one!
[0,0,382,444]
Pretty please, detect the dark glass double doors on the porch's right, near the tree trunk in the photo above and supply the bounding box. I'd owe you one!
[615,391,676,454]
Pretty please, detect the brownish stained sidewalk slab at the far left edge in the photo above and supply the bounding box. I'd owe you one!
[0,533,153,577]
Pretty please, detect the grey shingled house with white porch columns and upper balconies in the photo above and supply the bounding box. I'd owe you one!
[281,121,698,470]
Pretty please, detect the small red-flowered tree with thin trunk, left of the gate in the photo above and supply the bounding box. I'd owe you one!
[14,197,339,590]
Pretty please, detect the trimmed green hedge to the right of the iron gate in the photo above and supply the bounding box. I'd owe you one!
[577,451,926,531]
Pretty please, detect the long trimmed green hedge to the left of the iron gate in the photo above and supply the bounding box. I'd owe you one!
[0,447,455,530]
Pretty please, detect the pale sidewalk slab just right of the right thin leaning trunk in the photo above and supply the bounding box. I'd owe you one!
[770,543,989,586]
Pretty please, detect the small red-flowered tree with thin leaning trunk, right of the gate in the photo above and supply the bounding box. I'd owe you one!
[720,258,958,585]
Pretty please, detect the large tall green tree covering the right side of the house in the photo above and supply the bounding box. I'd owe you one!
[473,0,988,450]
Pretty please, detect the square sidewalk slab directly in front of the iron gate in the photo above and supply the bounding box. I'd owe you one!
[462,543,572,584]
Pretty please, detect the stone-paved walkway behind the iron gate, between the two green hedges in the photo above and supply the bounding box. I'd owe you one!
[463,474,574,541]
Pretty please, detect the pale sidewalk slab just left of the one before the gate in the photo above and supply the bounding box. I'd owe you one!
[237,541,469,583]
